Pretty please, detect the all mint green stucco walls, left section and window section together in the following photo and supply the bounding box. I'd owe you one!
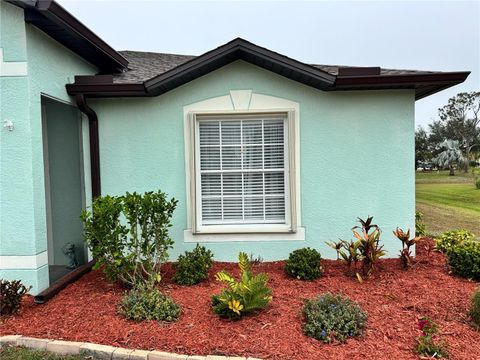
[0,1,414,294]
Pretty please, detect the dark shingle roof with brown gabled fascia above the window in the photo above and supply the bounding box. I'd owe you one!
[66,38,469,100]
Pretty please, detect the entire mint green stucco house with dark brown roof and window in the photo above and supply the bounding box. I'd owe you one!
[0,0,469,294]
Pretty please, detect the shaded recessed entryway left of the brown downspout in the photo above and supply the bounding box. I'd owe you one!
[42,97,87,284]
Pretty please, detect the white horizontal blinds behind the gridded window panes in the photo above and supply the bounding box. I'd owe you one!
[197,117,288,225]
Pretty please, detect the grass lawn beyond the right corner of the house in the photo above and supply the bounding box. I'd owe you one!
[416,171,480,237]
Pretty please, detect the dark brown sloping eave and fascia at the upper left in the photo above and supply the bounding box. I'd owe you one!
[7,0,128,72]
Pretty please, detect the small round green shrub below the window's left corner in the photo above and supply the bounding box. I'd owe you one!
[173,244,213,285]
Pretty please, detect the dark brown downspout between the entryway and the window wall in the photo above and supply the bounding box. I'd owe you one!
[75,94,101,201]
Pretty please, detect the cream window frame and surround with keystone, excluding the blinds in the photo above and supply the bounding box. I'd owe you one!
[184,90,305,242]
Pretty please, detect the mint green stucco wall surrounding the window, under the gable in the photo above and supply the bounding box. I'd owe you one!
[90,61,415,260]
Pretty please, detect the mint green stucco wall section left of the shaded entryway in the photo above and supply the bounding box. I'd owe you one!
[0,1,96,294]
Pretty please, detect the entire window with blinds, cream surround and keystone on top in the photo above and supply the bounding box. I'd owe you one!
[184,90,304,241]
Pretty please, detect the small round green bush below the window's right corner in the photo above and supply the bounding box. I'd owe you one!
[285,248,322,280]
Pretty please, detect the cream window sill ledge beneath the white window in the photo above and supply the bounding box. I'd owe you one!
[183,227,305,243]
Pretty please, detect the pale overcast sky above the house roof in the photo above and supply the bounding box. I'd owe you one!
[58,0,480,129]
